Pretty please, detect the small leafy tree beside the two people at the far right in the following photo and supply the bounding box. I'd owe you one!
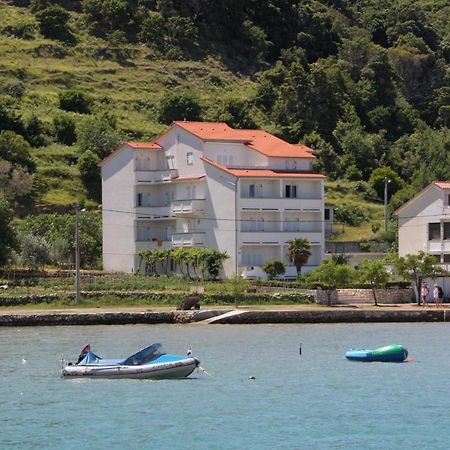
[394,251,448,306]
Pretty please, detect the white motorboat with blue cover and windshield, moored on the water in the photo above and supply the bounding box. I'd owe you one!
[62,343,200,379]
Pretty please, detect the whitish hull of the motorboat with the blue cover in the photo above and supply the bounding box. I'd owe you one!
[62,358,200,379]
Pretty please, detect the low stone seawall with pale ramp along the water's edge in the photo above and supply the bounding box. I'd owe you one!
[0,304,450,327]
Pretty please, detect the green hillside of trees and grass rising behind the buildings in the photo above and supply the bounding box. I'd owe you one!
[0,0,450,266]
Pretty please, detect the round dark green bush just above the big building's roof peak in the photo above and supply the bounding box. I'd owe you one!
[158,90,201,125]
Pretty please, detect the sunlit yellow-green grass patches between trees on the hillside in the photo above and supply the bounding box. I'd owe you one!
[0,1,383,240]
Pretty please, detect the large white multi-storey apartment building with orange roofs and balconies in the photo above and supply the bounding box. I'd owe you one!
[101,122,325,277]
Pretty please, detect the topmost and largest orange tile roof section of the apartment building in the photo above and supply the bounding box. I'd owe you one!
[174,122,315,158]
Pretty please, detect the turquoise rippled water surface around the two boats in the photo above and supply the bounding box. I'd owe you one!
[0,324,450,450]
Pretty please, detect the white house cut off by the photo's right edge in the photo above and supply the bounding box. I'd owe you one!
[396,181,450,269]
